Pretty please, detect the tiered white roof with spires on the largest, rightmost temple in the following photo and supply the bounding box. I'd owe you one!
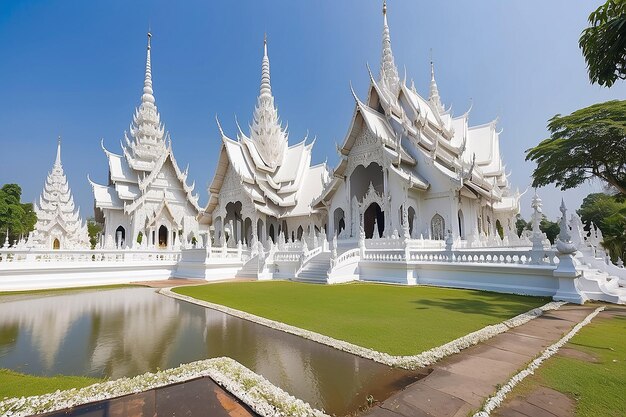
[314,3,519,211]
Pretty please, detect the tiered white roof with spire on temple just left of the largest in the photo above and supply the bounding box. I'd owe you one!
[205,39,328,221]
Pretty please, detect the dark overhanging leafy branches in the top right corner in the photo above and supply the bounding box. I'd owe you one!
[578,0,626,87]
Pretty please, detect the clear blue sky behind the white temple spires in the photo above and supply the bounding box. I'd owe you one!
[0,0,626,218]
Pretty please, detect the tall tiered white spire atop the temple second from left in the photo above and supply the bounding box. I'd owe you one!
[125,32,166,167]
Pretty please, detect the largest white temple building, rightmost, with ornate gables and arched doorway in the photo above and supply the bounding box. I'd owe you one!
[312,4,520,242]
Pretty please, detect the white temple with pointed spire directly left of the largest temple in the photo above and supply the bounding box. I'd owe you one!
[202,39,330,246]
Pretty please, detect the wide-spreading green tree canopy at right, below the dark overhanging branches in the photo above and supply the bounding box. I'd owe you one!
[526,100,626,195]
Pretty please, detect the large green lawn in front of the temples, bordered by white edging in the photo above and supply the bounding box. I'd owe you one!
[174,281,549,355]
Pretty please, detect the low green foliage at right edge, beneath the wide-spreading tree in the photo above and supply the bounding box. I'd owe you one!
[577,193,626,261]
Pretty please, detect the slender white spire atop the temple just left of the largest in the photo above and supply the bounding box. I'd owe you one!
[250,36,287,168]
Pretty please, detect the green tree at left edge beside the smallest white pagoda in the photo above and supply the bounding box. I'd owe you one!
[0,184,37,246]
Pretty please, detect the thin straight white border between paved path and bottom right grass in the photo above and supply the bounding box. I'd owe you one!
[473,306,605,417]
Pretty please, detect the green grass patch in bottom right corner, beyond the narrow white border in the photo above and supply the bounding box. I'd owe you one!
[509,310,626,417]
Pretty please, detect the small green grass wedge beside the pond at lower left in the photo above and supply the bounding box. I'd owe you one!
[0,369,103,401]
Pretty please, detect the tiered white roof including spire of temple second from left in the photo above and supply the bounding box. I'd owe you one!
[89,33,200,218]
